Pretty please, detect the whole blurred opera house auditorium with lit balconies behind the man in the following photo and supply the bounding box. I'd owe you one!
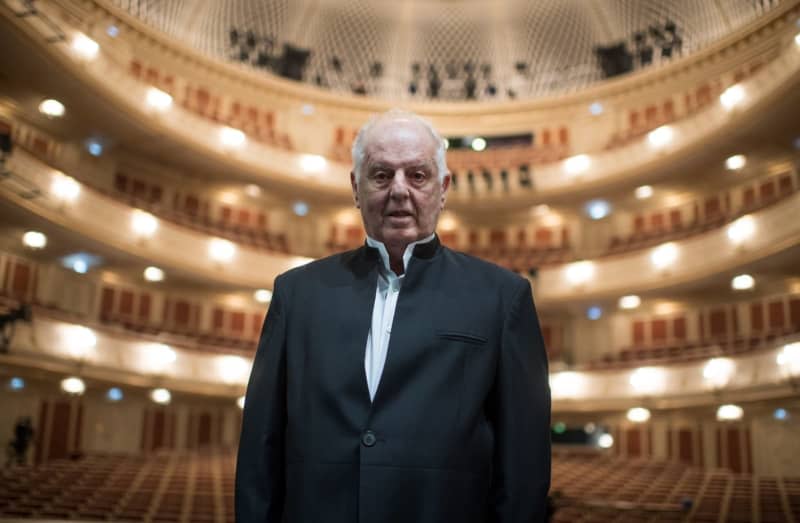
[0,0,800,523]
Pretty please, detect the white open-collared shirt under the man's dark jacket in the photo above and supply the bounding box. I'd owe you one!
[364,234,434,400]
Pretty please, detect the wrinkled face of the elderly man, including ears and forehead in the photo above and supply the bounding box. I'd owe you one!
[350,118,450,248]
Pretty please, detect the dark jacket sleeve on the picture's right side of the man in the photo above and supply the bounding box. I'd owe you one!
[487,281,550,523]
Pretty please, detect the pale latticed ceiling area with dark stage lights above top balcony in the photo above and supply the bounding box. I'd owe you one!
[106,0,786,101]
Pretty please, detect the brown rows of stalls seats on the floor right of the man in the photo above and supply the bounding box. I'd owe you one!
[551,451,800,523]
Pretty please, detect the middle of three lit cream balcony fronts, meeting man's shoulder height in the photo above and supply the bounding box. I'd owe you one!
[0,151,800,305]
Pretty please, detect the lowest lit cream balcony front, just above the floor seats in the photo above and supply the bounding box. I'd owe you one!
[0,304,800,412]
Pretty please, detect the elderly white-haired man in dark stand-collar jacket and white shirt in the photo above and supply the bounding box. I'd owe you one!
[236,111,550,523]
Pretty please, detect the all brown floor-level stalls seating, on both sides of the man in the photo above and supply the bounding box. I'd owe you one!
[0,448,800,523]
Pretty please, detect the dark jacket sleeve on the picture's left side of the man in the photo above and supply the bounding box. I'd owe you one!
[235,276,287,523]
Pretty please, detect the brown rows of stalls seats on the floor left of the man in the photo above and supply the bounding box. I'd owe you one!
[0,450,234,523]
